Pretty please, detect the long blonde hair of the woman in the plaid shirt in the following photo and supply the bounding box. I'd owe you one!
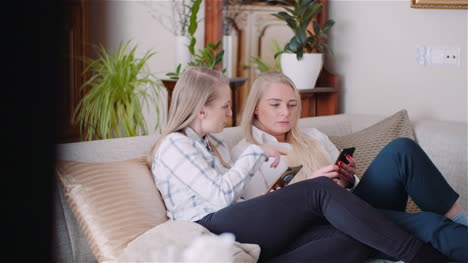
[146,67,229,167]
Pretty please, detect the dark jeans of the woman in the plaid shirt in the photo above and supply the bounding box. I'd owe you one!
[197,177,422,262]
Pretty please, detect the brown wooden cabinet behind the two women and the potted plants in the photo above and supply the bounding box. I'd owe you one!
[205,0,340,124]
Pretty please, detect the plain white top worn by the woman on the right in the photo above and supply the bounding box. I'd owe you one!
[231,126,359,199]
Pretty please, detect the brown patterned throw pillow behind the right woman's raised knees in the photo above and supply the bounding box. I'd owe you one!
[329,110,420,212]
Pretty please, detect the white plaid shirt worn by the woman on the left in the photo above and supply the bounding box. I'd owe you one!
[151,128,266,221]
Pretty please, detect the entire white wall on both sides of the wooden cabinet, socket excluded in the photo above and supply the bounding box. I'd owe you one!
[90,0,468,125]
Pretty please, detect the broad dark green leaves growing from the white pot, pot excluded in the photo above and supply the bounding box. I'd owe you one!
[272,0,335,60]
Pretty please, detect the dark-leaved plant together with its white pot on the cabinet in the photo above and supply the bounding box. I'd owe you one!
[272,0,335,89]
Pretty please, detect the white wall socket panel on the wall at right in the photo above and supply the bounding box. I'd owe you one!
[416,46,461,67]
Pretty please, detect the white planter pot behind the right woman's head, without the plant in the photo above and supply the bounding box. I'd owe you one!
[281,53,323,90]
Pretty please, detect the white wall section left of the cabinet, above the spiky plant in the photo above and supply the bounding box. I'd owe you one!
[89,0,205,77]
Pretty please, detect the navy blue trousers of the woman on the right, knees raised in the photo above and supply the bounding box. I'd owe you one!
[354,138,468,262]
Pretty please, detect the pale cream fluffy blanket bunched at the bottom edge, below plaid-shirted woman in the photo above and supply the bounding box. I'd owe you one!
[114,220,260,263]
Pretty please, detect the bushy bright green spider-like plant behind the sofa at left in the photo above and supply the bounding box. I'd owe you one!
[73,41,162,140]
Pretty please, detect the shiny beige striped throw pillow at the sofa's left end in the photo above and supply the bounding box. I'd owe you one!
[56,158,167,262]
